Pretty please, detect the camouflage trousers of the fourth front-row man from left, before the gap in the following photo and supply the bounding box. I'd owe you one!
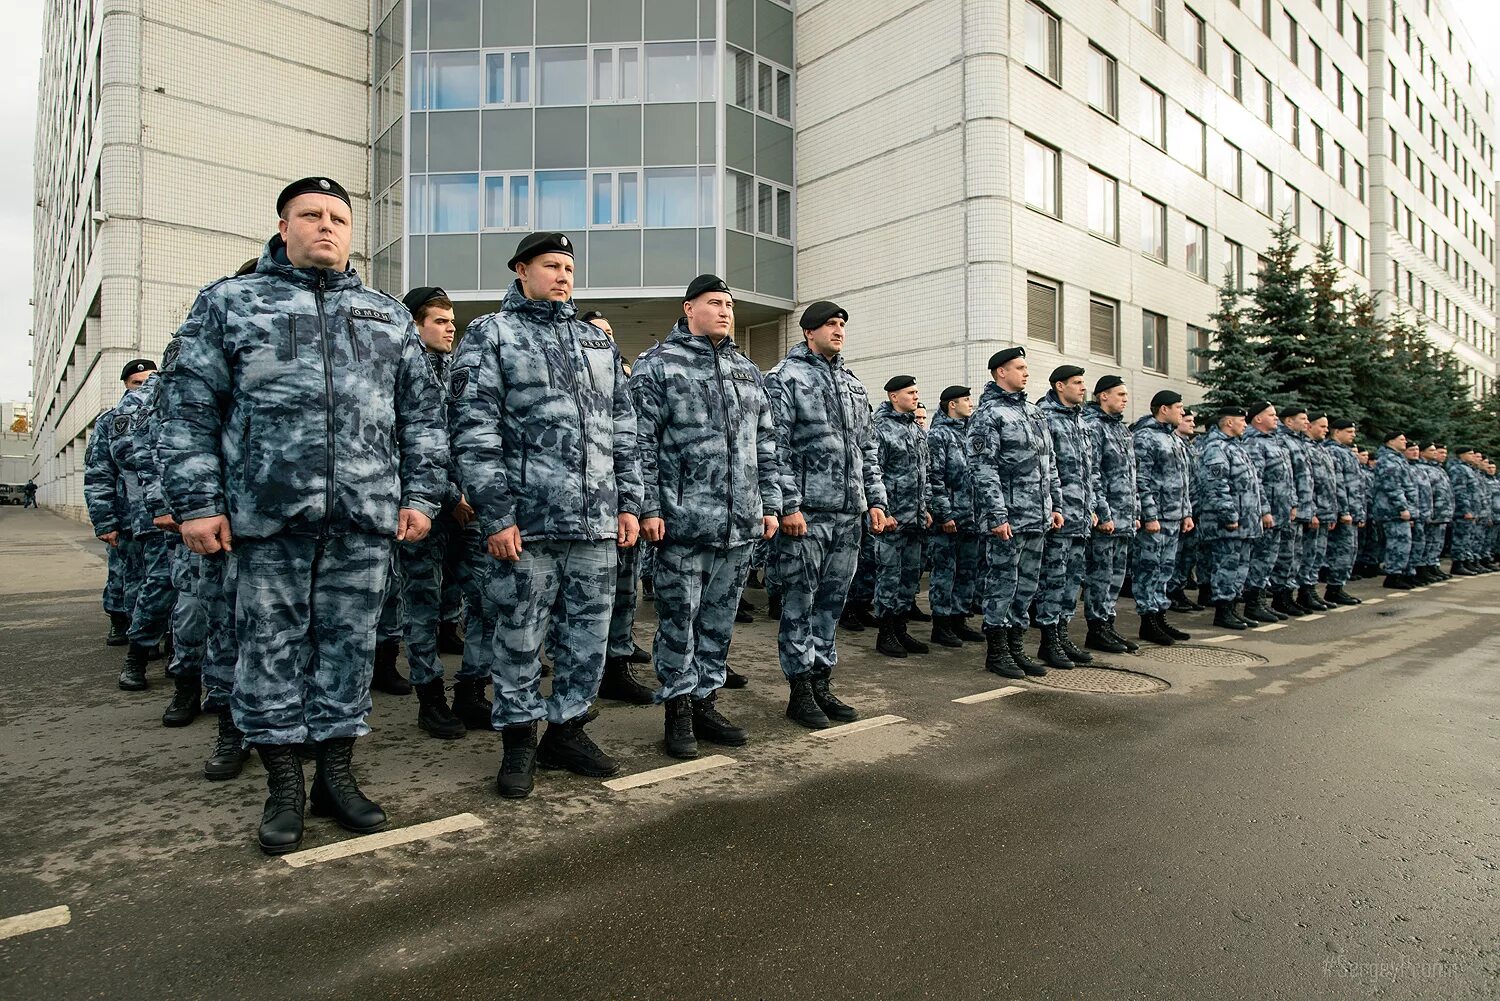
[768,512,863,678]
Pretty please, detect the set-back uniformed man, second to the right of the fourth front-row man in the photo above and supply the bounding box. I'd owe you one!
[927,386,984,647]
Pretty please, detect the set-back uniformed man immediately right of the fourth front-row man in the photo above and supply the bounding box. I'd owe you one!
[872,375,933,657]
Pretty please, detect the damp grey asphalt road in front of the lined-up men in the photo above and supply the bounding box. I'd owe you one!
[0,509,1500,999]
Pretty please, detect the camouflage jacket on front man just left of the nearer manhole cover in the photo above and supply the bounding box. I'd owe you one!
[969,383,1062,534]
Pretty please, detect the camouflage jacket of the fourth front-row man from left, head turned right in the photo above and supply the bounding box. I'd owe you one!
[765,342,887,515]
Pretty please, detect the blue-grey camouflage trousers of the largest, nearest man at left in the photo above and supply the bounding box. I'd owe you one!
[230,533,396,744]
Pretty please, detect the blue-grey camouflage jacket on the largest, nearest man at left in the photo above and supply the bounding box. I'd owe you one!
[158,236,447,539]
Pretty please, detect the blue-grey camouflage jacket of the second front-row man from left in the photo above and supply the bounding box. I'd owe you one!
[449,282,641,540]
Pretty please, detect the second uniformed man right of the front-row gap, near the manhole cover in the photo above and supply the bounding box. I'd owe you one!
[1037,365,1098,671]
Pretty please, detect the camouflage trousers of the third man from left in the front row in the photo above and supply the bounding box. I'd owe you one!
[651,542,753,702]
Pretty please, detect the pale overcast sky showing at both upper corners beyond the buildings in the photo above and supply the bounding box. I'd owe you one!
[0,0,1500,399]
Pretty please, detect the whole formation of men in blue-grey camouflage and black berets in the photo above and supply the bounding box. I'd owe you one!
[86,177,1500,854]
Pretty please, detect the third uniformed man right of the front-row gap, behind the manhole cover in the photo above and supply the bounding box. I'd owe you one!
[1083,375,1140,653]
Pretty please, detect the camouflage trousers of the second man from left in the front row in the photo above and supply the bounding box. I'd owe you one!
[486,539,617,729]
